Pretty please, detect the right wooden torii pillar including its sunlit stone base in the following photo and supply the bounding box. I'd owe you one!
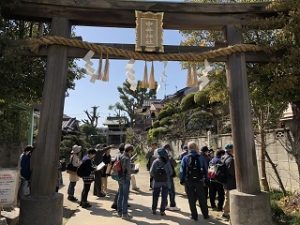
[225,25,272,225]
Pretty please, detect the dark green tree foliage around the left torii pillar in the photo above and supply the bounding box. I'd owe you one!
[0,0,81,146]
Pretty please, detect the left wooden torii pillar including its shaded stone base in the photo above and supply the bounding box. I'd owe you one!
[20,17,71,225]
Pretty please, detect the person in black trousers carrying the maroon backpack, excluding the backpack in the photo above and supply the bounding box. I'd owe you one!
[208,149,225,211]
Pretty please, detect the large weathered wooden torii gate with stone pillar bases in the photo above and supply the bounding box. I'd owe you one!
[2,0,276,225]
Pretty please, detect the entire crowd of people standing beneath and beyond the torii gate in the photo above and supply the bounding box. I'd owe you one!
[20,141,236,221]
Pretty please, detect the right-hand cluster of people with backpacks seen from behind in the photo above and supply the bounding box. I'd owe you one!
[146,141,236,221]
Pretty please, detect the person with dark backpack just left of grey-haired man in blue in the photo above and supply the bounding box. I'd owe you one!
[150,148,173,216]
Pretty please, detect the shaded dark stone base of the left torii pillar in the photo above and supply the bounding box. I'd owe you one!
[20,193,63,225]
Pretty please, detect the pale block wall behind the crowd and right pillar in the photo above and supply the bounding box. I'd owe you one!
[171,131,300,191]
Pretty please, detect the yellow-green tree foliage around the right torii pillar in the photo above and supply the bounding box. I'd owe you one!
[183,0,300,190]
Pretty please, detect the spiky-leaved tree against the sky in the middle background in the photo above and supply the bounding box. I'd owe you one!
[115,81,156,127]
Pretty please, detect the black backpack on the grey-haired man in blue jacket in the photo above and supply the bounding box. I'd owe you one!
[186,155,204,183]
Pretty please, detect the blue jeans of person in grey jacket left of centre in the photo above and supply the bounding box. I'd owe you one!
[118,179,130,215]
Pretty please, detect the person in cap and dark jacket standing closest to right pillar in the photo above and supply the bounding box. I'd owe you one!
[221,144,236,219]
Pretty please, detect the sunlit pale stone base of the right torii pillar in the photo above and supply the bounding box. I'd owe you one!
[230,190,273,225]
